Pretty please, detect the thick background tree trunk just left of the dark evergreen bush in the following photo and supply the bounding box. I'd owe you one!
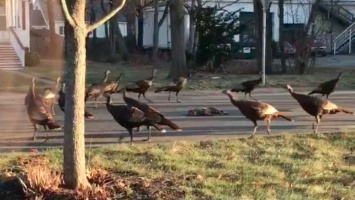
[169,0,187,78]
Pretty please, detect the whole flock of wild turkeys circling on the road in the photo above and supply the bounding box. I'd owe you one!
[25,69,354,144]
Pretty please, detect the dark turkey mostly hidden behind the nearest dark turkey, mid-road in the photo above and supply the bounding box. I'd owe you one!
[122,89,181,132]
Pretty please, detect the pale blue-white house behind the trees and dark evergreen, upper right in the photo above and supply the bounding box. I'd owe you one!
[143,0,355,52]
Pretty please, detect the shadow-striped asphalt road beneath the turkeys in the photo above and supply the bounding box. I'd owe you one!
[0,89,355,152]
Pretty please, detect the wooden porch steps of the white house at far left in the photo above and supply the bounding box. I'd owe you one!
[0,44,23,71]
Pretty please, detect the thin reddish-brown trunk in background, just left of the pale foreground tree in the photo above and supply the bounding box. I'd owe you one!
[47,0,57,58]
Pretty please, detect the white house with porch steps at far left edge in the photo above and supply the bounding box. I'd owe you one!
[0,0,31,70]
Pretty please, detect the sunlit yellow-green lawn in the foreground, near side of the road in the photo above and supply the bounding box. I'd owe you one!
[0,132,355,200]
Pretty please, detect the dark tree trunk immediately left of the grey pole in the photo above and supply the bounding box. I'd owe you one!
[253,0,263,71]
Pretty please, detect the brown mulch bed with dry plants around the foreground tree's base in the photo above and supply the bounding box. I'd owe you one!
[0,156,185,200]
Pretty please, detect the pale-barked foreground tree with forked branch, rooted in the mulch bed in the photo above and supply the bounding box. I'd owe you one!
[61,0,126,189]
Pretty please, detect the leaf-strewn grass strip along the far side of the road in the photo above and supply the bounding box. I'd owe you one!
[0,60,355,90]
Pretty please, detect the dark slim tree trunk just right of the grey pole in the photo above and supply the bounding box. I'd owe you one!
[279,0,287,73]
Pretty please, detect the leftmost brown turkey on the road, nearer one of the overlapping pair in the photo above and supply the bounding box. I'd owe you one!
[25,78,61,141]
